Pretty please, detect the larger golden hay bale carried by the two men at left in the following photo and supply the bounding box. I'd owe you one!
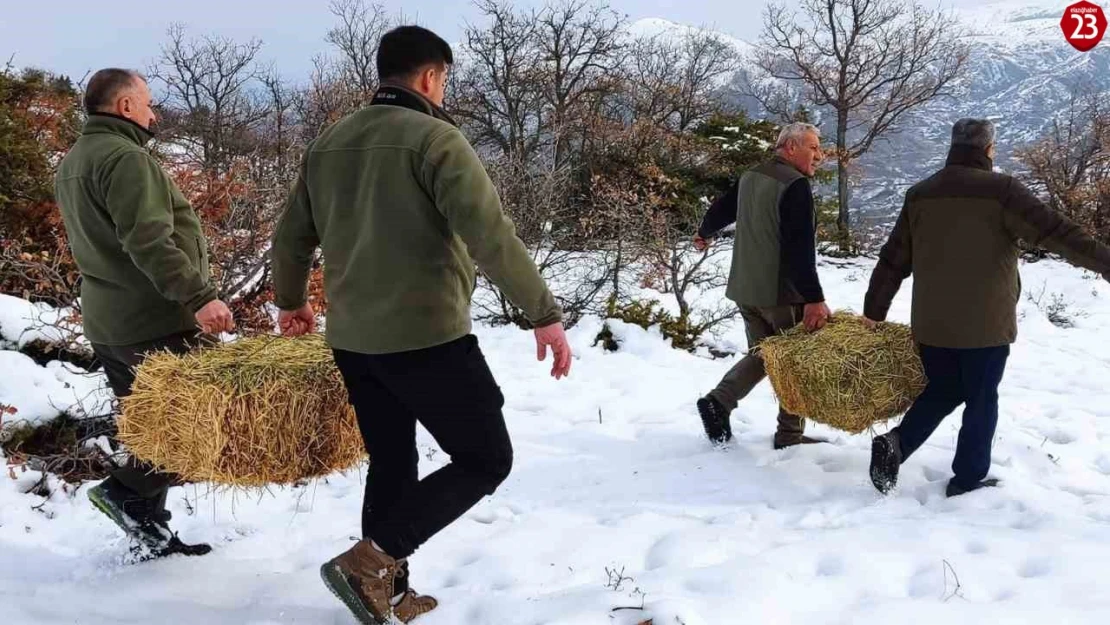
[119,335,365,487]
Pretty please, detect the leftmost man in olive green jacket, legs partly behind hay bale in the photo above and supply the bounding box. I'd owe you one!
[56,69,233,555]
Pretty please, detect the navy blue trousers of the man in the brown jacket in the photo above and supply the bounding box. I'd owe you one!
[898,345,1010,487]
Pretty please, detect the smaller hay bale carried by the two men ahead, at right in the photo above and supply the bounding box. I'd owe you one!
[758,312,926,434]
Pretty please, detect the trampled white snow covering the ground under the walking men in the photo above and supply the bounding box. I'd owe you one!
[0,255,1110,625]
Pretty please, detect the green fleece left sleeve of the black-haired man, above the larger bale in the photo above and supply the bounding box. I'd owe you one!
[270,152,320,311]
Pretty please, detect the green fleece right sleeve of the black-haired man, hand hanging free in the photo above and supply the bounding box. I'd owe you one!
[422,129,563,327]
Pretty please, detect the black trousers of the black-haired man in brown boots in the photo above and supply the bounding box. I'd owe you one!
[335,335,513,558]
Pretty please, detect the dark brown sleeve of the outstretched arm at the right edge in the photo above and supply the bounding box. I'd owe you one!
[1002,180,1110,274]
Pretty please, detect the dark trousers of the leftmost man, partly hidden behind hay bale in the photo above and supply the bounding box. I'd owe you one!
[92,332,212,508]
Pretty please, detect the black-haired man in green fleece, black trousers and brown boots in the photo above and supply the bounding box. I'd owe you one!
[273,27,571,623]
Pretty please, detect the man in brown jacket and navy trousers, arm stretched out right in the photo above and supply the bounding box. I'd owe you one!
[864,119,1110,496]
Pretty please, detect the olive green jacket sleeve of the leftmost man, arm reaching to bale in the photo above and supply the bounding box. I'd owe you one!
[103,151,216,313]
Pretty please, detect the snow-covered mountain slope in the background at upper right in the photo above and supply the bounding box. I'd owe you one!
[632,0,1110,218]
